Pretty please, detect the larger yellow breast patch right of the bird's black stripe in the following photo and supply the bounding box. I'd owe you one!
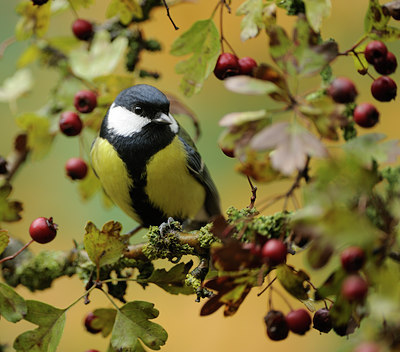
[146,137,205,218]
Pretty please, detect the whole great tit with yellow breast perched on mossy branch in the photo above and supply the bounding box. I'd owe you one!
[90,84,221,228]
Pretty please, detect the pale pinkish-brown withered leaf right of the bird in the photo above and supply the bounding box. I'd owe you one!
[250,122,328,176]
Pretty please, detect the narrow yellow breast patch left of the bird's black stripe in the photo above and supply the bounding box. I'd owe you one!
[90,137,140,222]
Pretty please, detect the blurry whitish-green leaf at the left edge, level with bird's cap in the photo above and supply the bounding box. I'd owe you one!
[0,68,33,103]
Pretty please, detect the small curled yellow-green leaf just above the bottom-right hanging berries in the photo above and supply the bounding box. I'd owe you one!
[276,264,310,300]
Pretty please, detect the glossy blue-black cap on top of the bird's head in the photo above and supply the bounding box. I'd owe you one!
[114,84,169,117]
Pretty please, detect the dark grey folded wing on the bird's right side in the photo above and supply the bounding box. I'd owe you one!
[178,127,221,217]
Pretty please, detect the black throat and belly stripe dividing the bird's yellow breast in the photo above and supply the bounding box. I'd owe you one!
[100,119,185,227]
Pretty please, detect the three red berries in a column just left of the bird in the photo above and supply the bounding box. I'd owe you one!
[59,90,97,180]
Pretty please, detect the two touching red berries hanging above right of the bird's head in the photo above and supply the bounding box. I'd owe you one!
[214,53,257,80]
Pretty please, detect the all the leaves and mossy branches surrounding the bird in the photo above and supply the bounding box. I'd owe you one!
[0,0,400,351]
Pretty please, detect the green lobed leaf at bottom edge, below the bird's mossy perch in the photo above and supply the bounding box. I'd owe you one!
[111,301,168,352]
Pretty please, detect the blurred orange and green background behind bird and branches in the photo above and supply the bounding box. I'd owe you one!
[0,0,400,352]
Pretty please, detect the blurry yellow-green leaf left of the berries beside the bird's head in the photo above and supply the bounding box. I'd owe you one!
[16,113,54,160]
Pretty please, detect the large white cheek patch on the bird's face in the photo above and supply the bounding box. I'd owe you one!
[107,103,151,137]
